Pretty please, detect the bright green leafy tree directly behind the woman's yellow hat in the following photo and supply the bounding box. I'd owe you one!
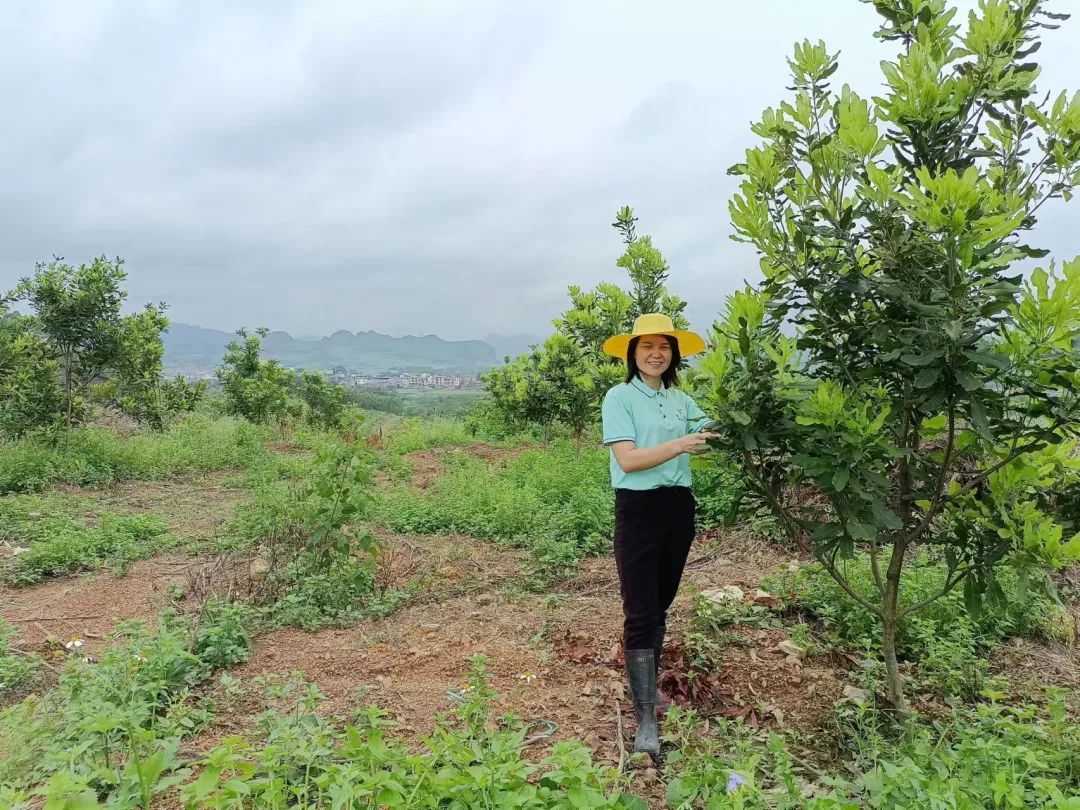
[483,206,687,434]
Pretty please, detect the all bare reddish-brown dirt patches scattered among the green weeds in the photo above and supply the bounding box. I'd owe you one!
[0,448,1080,807]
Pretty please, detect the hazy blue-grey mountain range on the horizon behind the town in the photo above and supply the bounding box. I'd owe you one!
[163,323,501,374]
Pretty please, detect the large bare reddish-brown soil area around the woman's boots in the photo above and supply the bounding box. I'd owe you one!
[181,534,840,807]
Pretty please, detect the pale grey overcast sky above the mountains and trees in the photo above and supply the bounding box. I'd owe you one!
[0,0,1080,339]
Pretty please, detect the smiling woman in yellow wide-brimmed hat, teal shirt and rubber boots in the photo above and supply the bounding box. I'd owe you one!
[603,313,715,758]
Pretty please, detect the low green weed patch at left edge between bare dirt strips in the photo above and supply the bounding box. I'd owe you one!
[0,496,173,584]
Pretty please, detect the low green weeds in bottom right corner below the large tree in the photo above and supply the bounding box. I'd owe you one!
[665,691,1080,810]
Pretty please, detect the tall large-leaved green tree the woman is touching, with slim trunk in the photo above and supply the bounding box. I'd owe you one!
[701,0,1080,706]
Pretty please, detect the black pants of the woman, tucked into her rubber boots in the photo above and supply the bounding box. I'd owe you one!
[615,487,696,650]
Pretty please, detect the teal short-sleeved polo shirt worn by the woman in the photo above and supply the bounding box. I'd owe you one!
[600,377,706,489]
